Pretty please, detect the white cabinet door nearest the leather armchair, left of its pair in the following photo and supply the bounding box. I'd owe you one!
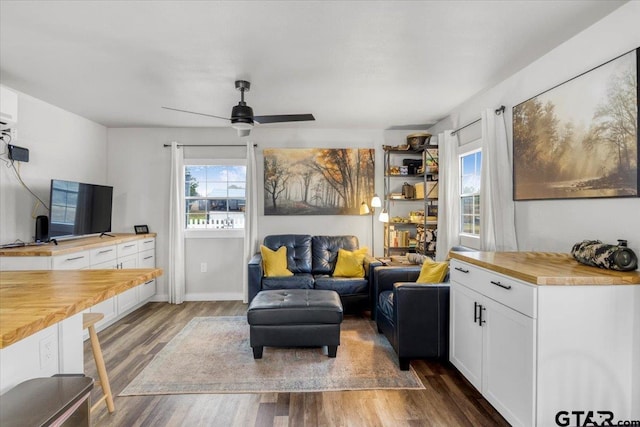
[449,282,483,390]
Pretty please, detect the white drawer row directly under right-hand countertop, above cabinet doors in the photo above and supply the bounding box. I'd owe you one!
[451,260,537,318]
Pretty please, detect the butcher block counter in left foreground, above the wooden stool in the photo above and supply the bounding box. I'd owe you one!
[0,268,162,348]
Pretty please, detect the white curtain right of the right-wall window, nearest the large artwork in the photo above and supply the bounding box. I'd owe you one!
[480,109,518,251]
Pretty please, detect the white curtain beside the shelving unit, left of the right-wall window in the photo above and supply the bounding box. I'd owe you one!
[436,130,460,261]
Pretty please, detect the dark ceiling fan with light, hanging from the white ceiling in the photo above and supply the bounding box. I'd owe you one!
[162,80,315,136]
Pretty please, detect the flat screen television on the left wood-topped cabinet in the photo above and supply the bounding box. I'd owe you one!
[49,179,113,238]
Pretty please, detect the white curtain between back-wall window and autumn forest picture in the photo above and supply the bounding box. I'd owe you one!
[242,142,258,302]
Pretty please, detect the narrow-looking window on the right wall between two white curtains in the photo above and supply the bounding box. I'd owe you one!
[460,149,482,237]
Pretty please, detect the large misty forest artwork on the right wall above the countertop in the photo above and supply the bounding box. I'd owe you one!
[513,49,640,200]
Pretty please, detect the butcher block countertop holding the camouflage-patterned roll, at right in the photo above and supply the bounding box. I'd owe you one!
[449,252,640,285]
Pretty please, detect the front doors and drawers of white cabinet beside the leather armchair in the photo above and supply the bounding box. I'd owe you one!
[450,260,536,426]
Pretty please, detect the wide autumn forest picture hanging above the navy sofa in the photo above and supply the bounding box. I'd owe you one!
[263,148,375,215]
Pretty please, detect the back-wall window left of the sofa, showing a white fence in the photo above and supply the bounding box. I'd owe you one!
[184,160,247,230]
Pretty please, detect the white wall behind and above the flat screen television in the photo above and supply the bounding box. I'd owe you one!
[0,84,107,243]
